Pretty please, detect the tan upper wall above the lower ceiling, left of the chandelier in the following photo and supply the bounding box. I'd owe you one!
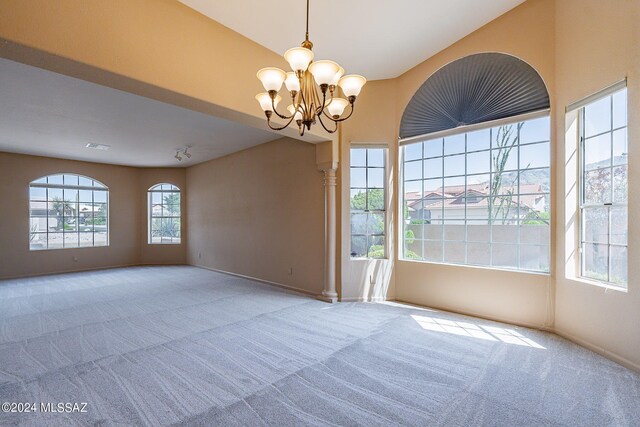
[0,0,329,142]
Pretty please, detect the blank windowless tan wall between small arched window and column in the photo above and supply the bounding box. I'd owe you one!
[187,138,324,294]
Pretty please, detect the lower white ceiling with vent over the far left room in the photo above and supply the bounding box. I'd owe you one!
[0,58,281,167]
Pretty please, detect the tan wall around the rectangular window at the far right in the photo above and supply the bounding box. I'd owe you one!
[554,0,640,370]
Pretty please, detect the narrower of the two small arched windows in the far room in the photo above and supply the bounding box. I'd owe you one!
[148,184,181,244]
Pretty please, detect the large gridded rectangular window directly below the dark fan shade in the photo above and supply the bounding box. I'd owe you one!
[402,116,550,272]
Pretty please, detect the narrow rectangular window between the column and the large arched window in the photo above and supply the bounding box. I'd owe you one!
[350,148,386,258]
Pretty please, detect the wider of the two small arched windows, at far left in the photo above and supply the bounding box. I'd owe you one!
[29,173,109,250]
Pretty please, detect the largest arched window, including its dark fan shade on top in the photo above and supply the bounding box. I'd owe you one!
[400,53,551,272]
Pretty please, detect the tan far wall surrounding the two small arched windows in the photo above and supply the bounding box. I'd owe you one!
[0,152,186,278]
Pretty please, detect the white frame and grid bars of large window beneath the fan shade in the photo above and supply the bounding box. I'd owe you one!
[398,110,553,275]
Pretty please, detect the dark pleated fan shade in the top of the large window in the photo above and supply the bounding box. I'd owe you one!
[400,53,549,139]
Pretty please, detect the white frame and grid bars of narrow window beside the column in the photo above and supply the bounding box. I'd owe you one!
[349,147,389,259]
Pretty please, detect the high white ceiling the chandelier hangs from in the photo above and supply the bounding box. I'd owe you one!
[180,0,524,80]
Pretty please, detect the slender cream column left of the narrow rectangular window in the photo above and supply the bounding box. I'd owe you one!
[317,162,338,303]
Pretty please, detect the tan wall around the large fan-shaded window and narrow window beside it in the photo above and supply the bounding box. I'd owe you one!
[341,0,555,327]
